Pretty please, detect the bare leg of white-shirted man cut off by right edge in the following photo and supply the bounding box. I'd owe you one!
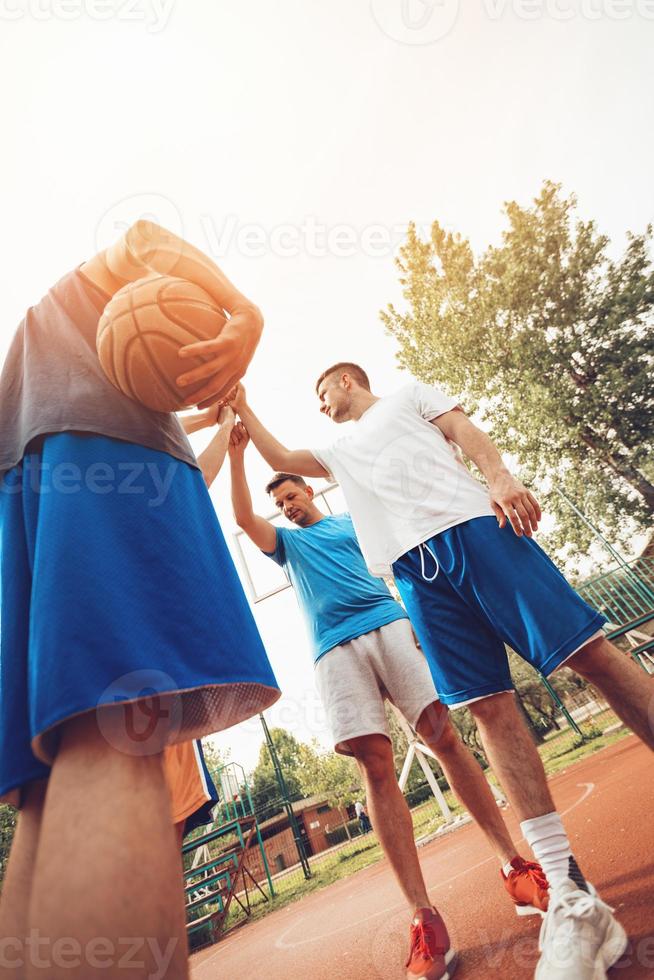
[565,638,654,749]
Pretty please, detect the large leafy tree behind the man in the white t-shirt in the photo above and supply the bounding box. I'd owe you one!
[381,181,654,558]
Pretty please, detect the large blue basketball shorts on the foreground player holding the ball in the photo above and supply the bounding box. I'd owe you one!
[0,432,279,802]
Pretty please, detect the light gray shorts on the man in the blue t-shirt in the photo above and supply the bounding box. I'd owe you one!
[316,619,438,755]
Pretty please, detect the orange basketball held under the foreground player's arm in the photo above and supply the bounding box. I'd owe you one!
[96,276,227,412]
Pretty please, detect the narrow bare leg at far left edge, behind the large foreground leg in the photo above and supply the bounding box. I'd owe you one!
[0,779,48,980]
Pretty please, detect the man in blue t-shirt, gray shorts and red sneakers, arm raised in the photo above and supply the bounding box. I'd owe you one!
[229,423,548,980]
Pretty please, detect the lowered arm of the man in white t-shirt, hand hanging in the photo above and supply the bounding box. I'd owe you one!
[432,409,541,538]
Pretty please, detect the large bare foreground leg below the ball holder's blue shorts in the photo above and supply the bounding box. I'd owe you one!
[26,713,188,980]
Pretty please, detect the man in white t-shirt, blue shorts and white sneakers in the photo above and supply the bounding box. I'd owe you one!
[234,362,654,980]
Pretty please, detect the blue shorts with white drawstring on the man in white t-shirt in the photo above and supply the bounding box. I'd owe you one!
[393,517,606,706]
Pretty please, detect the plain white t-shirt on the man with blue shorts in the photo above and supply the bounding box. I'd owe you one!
[311,381,494,575]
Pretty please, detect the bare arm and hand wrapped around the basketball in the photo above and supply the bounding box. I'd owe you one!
[82,221,263,408]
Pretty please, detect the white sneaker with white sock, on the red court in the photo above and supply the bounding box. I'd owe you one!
[535,878,628,980]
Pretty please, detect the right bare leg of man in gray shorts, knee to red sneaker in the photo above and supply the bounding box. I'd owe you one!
[416,701,518,865]
